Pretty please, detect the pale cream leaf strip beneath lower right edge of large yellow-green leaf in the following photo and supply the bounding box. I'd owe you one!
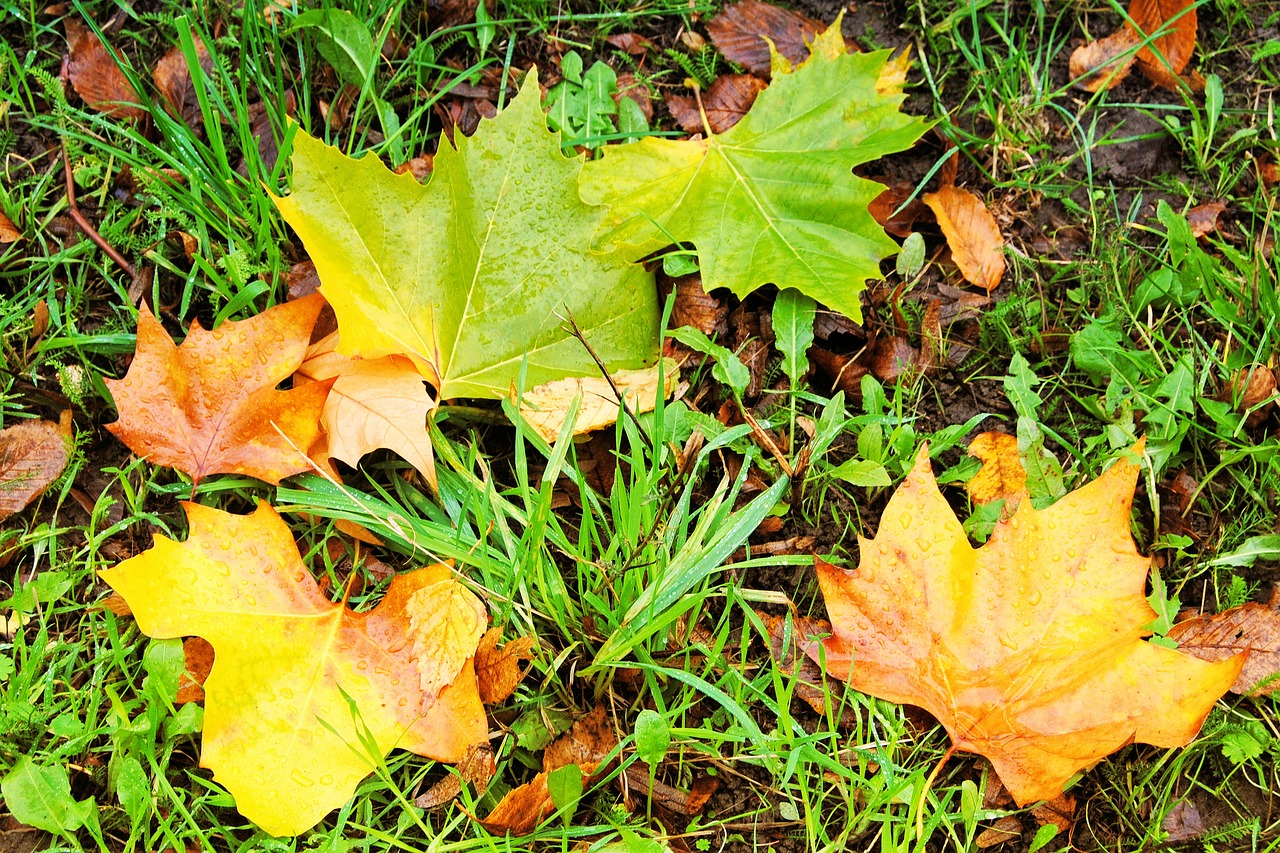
[511,359,680,443]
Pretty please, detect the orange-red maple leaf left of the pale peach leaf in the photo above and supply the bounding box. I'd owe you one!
[106,296,332,483]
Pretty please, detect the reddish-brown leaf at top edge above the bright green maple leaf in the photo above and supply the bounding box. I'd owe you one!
[707,0,826,77]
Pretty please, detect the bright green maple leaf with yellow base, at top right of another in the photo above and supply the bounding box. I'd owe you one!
[582,20,928,319]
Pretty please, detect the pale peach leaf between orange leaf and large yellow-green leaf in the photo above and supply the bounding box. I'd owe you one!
[297,332,436,489]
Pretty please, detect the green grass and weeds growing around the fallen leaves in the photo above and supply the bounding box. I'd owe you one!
[0,0,1280,853]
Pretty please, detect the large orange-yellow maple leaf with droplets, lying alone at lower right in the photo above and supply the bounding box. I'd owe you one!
[808,450,1244,804]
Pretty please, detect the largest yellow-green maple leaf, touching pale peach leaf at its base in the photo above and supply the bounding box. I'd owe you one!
[276,73,658,398]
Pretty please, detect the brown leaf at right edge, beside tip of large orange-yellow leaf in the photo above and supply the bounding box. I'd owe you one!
[1167,602,1280,694]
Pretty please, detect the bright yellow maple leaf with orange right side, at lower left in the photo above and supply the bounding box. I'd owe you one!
[101,503,488,835]
